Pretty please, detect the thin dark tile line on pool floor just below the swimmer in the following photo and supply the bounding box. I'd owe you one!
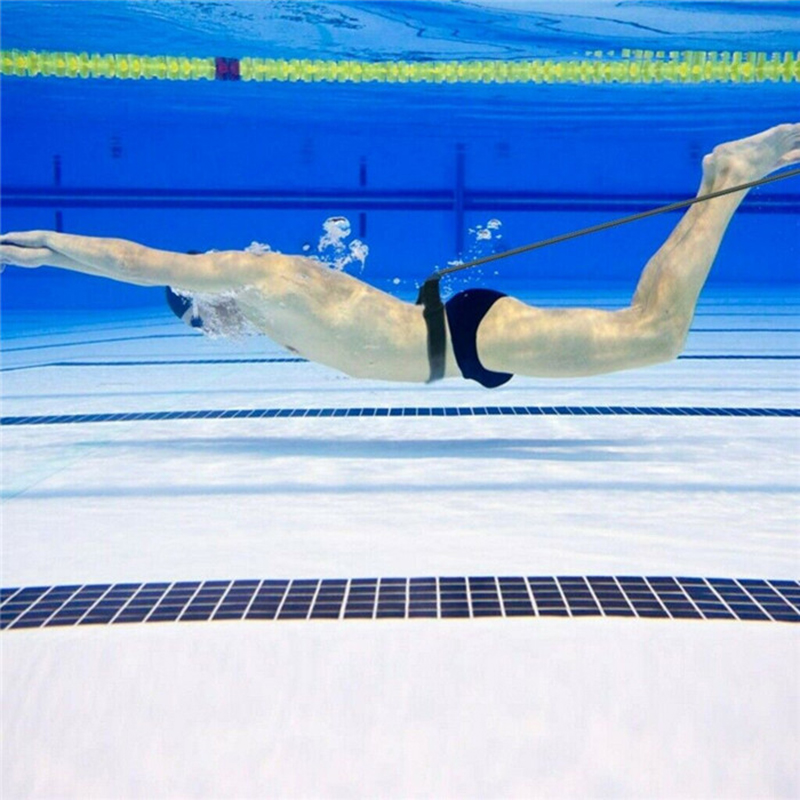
[0,406,800,426]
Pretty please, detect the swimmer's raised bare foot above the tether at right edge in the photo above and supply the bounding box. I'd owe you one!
[703,123,800,190]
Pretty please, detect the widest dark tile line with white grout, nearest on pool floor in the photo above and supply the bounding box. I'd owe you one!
[0,575,800,630]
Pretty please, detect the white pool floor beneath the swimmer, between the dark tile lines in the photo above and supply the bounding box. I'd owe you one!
[2,290,800,797]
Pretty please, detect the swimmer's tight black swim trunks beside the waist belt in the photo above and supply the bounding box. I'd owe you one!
[444,289,514,389]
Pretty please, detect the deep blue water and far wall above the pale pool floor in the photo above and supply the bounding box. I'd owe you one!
[1,2,800,311]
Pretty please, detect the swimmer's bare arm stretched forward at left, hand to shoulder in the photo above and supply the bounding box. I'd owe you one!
[0,231,268,292]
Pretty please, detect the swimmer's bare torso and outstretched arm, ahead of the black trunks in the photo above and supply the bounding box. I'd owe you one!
[0,231,438,382]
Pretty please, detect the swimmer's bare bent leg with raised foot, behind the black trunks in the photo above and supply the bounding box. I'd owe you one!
[477,124,800,377]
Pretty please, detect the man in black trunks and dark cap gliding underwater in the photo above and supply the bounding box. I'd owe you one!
[0,123,800,387]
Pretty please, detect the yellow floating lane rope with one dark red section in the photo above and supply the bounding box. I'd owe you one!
[0,49,800,85]
